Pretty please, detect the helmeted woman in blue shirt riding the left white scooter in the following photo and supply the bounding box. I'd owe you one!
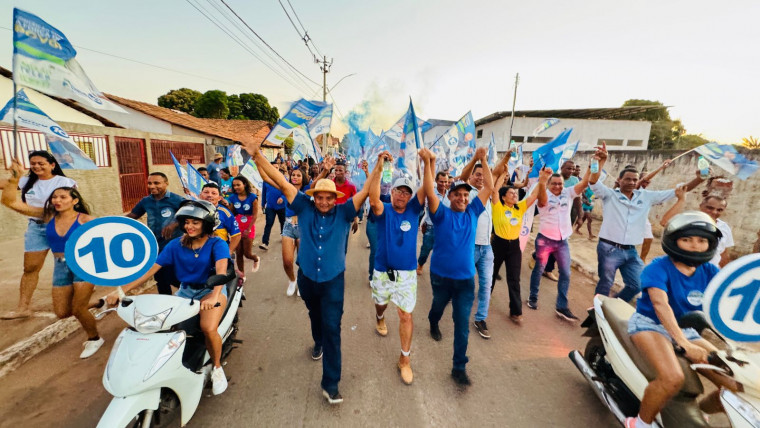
[106,200,230,395]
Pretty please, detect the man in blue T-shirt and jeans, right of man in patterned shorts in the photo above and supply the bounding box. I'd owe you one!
[420,147,493,386]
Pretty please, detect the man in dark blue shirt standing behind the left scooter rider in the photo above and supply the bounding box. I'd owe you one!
[127,172,184,294]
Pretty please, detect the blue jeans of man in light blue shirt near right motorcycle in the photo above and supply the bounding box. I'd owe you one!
[594,241,644,302]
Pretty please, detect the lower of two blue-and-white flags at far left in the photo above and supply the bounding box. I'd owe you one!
[0,89,98,169]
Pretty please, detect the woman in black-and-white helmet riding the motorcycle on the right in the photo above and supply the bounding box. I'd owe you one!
[625,211,736,428]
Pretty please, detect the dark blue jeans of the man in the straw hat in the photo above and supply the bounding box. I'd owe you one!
[298,269,344,394]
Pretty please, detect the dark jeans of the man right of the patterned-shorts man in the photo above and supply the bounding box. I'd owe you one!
[428,272,475,370]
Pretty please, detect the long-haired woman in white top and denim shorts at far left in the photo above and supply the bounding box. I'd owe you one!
[0,155,77,320]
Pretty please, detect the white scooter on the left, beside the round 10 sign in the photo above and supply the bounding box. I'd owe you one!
[98,262,245,428]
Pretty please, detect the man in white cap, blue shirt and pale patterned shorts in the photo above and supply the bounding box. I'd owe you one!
[369,159,431,385]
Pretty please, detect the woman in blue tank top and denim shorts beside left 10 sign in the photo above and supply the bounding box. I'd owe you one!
[2,177,105,358]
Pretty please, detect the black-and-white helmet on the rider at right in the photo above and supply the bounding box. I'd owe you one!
[662,211,723,266]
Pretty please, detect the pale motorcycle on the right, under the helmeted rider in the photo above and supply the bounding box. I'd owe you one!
[569,295,760,428]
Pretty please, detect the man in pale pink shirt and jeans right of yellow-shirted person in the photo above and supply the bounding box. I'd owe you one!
[528,168,590,321]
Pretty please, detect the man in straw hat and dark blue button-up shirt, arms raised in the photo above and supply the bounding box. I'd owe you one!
[245,139,382,404]
